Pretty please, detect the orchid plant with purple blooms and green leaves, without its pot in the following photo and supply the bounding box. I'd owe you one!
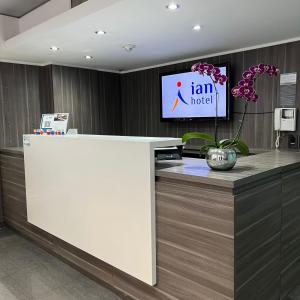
[182,63,279,155]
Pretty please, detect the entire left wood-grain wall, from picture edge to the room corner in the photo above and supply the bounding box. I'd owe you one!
[0,62,122,147]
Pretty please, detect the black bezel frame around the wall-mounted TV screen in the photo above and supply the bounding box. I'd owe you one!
[159,62,232,122]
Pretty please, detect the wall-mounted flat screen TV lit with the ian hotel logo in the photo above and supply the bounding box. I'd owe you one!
[160,65,230,121]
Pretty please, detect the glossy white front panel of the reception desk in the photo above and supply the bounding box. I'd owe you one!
[24,135,180,285]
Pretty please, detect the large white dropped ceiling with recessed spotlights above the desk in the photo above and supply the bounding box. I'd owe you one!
[0,0,300,71]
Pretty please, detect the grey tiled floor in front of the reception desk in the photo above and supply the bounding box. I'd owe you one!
[0,229,121,300]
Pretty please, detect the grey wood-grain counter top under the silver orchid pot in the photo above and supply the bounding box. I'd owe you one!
[156,151,300,187]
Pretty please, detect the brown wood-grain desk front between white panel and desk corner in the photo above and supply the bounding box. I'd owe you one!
[156,179,234,299]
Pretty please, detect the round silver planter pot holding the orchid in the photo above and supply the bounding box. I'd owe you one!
[206,148,237,171]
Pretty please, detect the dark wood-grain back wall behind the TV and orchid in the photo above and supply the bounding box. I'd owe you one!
[121,42,300,149]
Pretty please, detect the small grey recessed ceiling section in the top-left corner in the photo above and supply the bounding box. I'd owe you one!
[0,0,49,18]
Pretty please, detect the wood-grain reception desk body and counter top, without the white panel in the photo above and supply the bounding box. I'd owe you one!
[0,143,300,300]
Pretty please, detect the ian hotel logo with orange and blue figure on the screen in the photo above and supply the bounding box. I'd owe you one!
[172,81,213,112]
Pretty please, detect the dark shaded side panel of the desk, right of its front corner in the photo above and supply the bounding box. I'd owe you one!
[235,174,282,300]
